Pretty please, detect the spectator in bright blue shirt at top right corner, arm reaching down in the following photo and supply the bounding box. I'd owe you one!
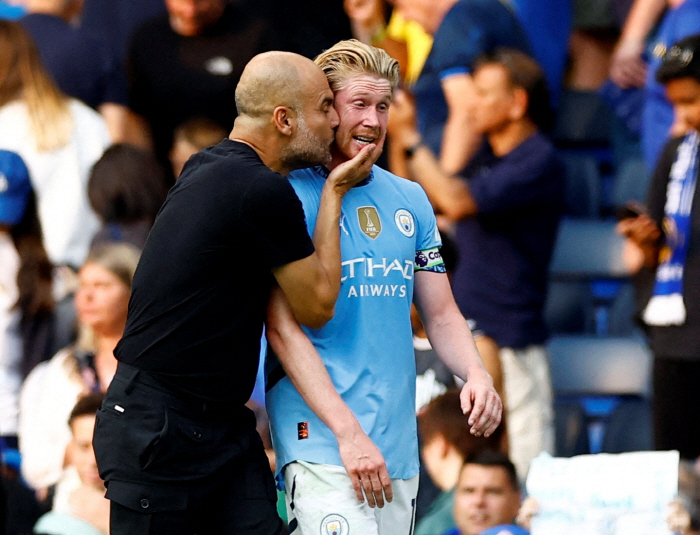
[610,0,700,172]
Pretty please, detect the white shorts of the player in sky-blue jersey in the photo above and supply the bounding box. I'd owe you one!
[283,461,418,535]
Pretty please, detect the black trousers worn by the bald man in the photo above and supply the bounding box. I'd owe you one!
[93,364,282,535]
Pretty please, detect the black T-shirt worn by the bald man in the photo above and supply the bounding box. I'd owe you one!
[115,139,314,404]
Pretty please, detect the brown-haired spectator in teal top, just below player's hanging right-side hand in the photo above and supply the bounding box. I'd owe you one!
[415,389,503,535]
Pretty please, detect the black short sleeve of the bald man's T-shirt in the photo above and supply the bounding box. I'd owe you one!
[242,175,314,268]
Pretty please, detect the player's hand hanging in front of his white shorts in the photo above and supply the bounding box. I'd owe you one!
[336,429,394,507]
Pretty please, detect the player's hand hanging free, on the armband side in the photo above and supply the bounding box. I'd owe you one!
[460,370,503,437]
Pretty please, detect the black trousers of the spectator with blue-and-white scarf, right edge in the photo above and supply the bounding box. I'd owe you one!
[652,357,700,460]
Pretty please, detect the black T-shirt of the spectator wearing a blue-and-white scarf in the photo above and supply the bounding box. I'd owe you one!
[638,137,700,360]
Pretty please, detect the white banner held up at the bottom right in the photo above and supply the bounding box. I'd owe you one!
[526,451,679,535]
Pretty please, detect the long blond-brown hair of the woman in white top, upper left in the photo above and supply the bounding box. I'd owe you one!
[0,20,73,152]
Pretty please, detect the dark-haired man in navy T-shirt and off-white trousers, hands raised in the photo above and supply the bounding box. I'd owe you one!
[394,49,564,478]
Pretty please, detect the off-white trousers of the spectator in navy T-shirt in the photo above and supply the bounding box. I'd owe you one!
[500,346,554,481]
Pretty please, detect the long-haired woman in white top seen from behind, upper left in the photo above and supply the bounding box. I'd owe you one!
[0,21,109,267]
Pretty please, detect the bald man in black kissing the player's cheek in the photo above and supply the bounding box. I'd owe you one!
[94,52,379,535]
